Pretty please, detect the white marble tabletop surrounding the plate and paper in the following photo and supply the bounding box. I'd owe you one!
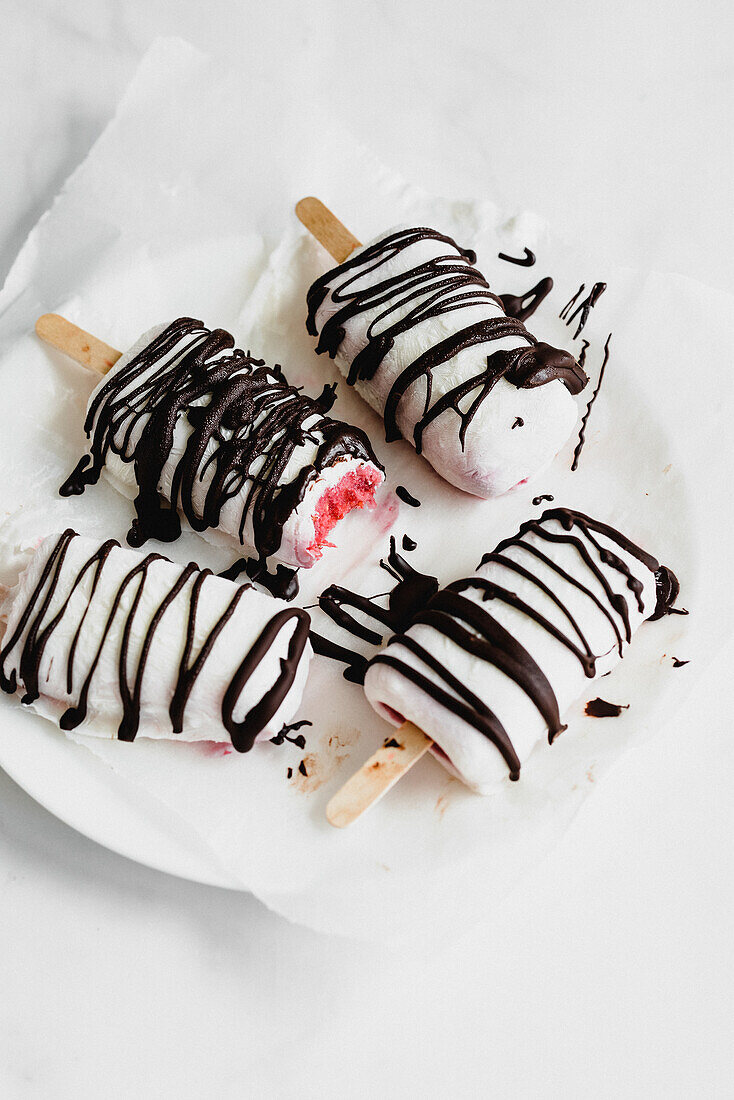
[0,0,734,1100]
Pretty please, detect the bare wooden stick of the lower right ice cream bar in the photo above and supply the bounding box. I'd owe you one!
[326,722,434,828]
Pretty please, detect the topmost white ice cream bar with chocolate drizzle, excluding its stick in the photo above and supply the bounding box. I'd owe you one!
[307,228,588,497]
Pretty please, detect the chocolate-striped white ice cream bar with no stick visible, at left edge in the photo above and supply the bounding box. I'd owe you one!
[0,530,311,752]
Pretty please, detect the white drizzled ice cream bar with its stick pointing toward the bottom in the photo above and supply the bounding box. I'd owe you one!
[364,508,678,793]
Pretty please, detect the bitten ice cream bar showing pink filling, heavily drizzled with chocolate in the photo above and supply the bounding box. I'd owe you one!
[62,317,384,567]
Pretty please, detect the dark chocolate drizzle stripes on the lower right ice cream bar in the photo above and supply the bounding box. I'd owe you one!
[371,508,677,779]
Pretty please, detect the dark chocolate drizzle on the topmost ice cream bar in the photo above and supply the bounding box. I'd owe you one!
[306,228,588,453]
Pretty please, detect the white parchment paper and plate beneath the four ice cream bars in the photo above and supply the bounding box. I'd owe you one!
[0,40,732,938]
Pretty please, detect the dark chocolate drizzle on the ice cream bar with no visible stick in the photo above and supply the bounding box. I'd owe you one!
[0,529,310,752]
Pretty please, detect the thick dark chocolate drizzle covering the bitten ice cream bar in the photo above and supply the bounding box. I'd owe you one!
[59,317,382,559]
